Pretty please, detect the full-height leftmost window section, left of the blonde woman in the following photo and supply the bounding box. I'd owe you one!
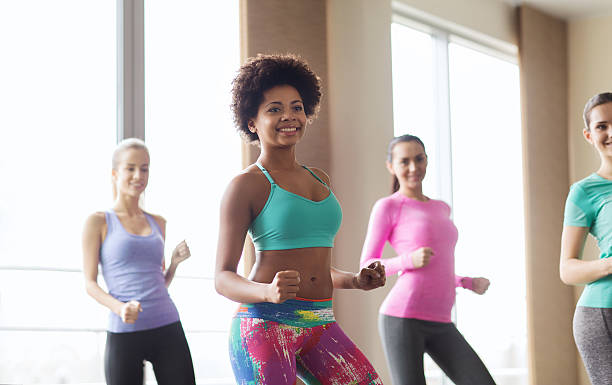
[0,0,117,383]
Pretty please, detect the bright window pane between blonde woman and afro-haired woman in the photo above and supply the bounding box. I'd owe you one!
[145,0,242,384]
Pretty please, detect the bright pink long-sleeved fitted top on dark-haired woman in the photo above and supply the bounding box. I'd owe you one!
[360,192,472,322]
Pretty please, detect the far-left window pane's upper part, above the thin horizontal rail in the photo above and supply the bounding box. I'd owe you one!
[0,0,117,268]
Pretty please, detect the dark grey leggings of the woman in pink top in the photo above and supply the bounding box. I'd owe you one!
[378,314,495,385]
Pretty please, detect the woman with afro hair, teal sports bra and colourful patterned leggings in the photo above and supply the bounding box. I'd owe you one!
[215,55,386,385]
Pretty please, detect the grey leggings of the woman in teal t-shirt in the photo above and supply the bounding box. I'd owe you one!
[574,306,612,385]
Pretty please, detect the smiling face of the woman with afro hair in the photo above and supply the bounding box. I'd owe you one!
[249,85,307,147]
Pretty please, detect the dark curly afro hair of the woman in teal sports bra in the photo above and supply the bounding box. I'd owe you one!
[231,54,321,143]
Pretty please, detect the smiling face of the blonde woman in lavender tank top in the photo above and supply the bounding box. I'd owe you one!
[113,148,149,197]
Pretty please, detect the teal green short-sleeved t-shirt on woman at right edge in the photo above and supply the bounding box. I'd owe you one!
[563,174,612,308]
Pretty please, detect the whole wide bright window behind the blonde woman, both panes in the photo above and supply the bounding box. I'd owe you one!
[0,0,241,384]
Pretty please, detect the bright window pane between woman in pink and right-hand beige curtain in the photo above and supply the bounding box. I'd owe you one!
[449,44,527,385]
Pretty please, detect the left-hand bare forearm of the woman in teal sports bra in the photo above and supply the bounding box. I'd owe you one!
[215,271,269,303]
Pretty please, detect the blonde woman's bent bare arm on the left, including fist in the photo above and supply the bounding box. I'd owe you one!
[82,212,141,323]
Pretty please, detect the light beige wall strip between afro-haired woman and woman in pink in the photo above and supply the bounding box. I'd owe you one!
[327,0,393,384]
